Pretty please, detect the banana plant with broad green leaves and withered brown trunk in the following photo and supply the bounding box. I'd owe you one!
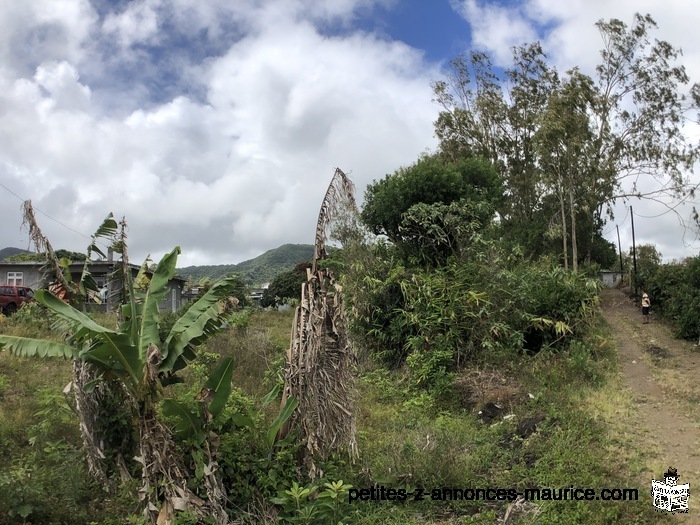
[0,247,243,523]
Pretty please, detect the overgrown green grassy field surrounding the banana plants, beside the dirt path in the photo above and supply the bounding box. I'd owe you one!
[0,304,660,524]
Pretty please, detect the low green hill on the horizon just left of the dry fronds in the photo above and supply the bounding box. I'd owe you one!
[177,244,314,286]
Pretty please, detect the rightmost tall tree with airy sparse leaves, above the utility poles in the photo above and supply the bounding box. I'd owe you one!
[594,14,700,205]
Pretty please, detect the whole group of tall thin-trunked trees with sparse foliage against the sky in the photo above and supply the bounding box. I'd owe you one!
[433,14,700,268]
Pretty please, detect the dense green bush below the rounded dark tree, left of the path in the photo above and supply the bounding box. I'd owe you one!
[345,232,598,390]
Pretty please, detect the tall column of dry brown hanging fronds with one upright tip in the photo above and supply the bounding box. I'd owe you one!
[278,169,357,479]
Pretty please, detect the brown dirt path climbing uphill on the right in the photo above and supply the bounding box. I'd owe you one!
[601,290,700,524]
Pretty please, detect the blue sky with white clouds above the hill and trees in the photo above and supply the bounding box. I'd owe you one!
[0,0,700,267]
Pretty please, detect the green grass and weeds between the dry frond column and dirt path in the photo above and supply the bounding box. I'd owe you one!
[350,322,657,524]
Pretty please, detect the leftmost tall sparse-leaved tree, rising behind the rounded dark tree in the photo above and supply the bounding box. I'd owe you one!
[433,44,559,232]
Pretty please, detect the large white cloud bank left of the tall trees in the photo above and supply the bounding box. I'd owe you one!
[0,0,439,265]
